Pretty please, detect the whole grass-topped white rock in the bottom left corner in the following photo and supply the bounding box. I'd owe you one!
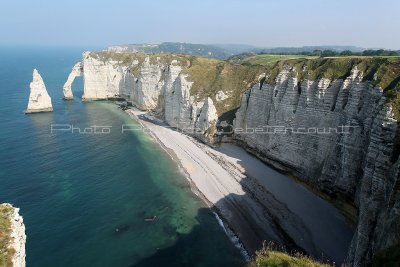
[0,203,26,267]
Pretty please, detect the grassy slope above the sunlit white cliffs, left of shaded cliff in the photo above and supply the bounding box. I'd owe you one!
[89,52,264,114]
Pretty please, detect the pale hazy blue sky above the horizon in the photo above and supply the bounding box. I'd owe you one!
[0,0,400,49]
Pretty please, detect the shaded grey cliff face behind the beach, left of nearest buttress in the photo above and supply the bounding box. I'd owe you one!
[234,66,378,198]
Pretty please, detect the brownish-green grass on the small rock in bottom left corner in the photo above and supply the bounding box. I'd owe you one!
[0,205,15,266]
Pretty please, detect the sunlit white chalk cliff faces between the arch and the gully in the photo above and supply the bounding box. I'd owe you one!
[83,52,218,141]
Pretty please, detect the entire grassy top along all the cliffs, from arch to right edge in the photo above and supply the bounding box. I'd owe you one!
[89,52,400,118]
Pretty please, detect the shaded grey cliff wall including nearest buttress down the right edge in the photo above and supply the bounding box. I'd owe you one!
[234,66,400,266]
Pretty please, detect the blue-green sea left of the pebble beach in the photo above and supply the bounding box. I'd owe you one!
[0,47,244,267]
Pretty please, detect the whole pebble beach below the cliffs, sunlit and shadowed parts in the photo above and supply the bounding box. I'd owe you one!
[125,108,352,263]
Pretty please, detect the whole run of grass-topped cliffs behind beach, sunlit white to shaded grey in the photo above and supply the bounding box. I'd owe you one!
[72,52,400,266]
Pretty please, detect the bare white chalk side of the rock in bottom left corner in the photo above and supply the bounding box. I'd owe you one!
[0,203,26,267]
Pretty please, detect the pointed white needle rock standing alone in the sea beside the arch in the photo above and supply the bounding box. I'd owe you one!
[25,69,53,113]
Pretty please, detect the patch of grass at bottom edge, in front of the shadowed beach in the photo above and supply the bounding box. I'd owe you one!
[246,247,333,267]
